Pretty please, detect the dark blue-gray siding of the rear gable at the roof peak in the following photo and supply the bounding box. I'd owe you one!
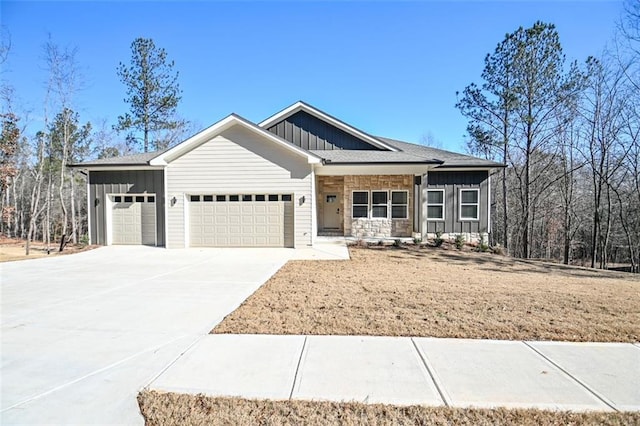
[267,111,380,151]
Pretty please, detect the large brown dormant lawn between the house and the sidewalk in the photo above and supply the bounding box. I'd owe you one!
[212,248,640,342]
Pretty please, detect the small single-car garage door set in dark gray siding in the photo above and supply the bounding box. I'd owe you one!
[111,194,157,246]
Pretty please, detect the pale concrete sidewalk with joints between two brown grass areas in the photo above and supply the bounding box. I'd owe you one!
[148,335,640,411]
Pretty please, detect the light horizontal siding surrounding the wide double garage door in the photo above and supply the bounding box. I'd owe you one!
[165,126,313,248]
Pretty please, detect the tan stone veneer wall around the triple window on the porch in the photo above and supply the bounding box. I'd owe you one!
[343,175,414,238]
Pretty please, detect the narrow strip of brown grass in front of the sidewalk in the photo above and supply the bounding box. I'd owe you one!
[138,391,640,426]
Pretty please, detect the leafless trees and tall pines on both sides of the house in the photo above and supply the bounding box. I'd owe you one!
[0,4,640,273]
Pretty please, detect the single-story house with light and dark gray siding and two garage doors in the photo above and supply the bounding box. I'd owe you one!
[74,102,503,248]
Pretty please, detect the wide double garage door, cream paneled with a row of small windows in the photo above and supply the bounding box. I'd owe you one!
[189,194,293,247]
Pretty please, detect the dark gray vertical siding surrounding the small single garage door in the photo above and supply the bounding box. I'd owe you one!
[88,170,165,246]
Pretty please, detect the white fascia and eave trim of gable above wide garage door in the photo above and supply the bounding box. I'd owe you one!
[149,114,322,166]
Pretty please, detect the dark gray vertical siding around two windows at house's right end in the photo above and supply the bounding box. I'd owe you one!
[422,170,489,234]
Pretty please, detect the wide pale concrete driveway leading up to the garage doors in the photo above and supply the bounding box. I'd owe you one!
[0,247,293,425]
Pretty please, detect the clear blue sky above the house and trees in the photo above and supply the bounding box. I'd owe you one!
[0,0,622,151]
